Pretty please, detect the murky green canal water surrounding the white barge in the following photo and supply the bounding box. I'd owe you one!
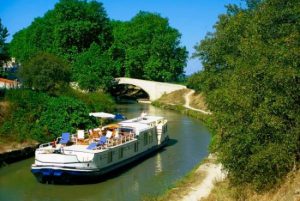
[0,104,210,201]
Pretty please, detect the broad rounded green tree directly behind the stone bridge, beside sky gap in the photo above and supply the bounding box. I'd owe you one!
[110,12,187,81]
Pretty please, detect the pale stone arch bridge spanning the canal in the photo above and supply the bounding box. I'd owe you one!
[115,77,186,101]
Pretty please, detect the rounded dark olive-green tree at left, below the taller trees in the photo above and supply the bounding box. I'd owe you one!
[19,53,70,93]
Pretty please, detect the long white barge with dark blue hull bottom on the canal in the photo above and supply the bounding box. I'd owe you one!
[31,115,169,183]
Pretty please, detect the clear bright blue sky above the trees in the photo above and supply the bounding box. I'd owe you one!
[0,0,243,75]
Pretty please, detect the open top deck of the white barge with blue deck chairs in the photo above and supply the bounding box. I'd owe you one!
[39,115,166,153]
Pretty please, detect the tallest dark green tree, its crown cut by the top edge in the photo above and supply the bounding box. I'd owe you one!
[53,0,112,60]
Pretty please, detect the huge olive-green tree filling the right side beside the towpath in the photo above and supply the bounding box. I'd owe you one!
[189,0,300,190]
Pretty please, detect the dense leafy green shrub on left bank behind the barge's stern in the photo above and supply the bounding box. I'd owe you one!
[0,90,96,142]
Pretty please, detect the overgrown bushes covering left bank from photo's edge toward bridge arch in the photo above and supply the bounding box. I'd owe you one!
[0,89,115,157]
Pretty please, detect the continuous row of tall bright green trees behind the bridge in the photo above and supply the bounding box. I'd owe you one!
[10,0,187,91]
